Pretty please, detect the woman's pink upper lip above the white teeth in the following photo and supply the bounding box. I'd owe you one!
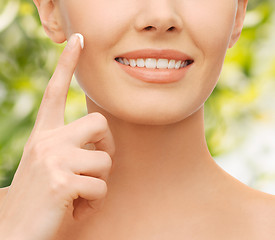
[116,48,193,61]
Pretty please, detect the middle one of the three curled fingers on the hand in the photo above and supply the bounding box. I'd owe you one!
[66,149,112,181]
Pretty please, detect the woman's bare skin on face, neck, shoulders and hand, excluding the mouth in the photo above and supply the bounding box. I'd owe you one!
[0,0,275,240]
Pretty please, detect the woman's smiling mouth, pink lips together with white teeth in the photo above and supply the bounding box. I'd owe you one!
[114,48,195,84]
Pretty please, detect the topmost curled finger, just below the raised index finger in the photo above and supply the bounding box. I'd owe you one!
[65,112,115,157]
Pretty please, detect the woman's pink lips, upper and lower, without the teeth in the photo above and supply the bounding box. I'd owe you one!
[115,49,194,83]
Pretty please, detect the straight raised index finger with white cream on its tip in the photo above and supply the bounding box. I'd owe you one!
[35,34,84,129]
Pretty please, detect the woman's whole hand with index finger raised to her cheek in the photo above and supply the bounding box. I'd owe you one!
[0,34,115,240]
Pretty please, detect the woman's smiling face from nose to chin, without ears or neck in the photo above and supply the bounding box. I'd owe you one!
[57,0,242,125]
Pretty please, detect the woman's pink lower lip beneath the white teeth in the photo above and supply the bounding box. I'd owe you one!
[116,61,193,83]
